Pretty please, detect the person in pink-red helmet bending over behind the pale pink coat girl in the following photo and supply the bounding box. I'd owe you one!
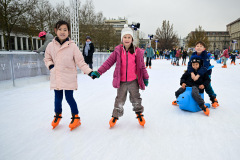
[36,31,54,53]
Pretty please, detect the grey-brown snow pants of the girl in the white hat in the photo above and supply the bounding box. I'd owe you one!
[112,80,144,118]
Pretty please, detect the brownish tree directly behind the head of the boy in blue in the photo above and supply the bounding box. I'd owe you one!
[188,26,210,48]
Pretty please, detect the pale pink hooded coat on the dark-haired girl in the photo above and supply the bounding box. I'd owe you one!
[44,39,92,90]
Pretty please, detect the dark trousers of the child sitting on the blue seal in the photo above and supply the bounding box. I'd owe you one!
[175,86,204,109]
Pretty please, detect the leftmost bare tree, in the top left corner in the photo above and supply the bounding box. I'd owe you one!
[0,0,37,50]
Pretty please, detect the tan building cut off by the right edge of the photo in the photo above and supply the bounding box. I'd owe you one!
[227,18,240,50]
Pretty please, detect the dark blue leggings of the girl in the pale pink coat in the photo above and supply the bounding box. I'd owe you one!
[54,90,78,114]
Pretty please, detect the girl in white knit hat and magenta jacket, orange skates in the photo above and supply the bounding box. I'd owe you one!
[93,24,149,128]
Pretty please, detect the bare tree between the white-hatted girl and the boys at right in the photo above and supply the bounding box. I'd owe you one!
[153,20,178,49]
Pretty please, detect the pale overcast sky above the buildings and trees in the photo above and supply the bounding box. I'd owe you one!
[49,0,240,38]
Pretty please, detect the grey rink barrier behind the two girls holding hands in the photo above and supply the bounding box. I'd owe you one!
[0,51,110,86]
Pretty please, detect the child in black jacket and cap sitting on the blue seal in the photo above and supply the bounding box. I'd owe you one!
[172,57,211,116]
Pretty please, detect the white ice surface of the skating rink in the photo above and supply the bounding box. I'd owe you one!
[0,60,240,160]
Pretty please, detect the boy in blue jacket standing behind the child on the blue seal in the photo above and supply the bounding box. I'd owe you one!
[187,41,219,108]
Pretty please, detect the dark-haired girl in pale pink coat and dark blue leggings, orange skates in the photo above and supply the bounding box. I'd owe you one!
[44,21,92,130]
